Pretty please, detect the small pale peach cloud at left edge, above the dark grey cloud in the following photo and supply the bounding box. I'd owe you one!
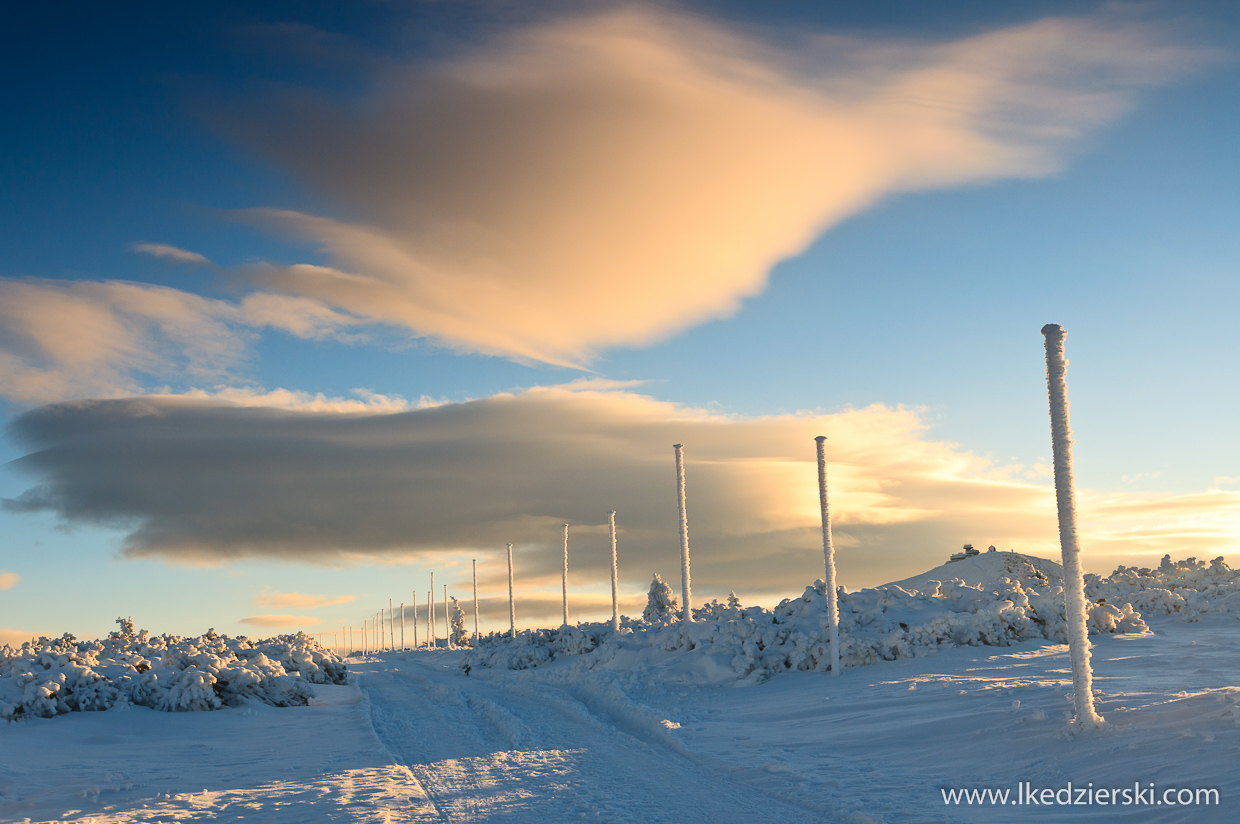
[0,279,360,404]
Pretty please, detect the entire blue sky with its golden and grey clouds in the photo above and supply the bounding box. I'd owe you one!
[0,0,1240,642]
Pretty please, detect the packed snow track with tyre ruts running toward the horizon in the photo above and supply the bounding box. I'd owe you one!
[353,654,822,824]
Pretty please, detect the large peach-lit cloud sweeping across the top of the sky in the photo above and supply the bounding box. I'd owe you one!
[215,9,1209,366]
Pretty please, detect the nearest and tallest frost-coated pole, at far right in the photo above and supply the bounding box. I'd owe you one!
[1042,323,1102,727]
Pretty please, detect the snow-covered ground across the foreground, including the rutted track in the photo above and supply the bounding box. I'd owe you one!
[0,560,1240,824]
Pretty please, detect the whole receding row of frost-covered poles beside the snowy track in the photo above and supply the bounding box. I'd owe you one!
[310,323,1104,727]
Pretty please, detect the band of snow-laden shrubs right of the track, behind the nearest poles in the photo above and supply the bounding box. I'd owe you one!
[461,553,1240,683]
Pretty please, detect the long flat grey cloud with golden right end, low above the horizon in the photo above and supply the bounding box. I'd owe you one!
[4,384,1240,595]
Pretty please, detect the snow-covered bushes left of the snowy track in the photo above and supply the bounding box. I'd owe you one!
[0,618,347,720]
